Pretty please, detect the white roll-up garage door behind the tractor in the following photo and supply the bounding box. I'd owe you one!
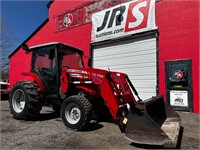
[92,35,157,99]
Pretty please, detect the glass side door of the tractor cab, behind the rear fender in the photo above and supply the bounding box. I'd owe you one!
[32,46,58,95]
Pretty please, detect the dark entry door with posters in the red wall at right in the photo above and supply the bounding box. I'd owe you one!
[165,60,193,112]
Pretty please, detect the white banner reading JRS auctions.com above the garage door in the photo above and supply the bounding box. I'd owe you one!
[92,0,156,42]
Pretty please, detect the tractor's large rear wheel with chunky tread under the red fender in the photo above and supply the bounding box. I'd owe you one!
[9,81,42,120]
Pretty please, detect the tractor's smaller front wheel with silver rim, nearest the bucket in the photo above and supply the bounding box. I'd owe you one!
[61,95,92,130]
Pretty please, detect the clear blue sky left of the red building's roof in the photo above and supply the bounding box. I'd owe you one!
[0,0,49,52]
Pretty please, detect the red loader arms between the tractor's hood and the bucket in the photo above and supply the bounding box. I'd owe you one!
[89,71,136,120]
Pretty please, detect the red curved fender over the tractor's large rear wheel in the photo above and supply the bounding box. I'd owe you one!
[21,72,44,95]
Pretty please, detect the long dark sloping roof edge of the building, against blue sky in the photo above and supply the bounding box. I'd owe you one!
[8,18,49,59]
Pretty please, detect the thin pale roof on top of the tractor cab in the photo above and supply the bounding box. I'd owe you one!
[29,42,83,53]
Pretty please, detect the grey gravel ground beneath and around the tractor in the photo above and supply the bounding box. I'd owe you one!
[0,98,200,150]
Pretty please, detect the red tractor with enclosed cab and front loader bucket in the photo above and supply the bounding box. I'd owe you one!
[9,42,180,147]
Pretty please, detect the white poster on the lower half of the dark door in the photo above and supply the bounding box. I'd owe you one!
[170,90,188,107]
